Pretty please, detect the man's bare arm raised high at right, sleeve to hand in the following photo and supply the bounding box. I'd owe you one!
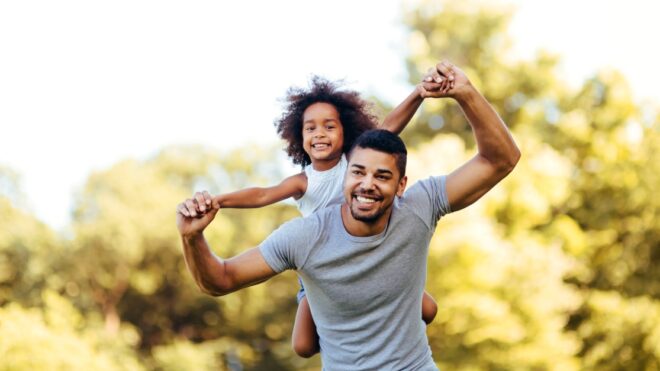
[422,61,520,211]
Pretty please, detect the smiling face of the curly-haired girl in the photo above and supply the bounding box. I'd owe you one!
[302,103,344,170]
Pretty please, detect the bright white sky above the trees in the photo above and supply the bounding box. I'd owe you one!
[0,0,660,229]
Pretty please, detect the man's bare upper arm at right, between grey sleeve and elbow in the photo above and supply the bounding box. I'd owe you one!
[446,155,506,211]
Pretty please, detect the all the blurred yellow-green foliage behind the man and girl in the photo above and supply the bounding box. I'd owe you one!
[0,0,660,370]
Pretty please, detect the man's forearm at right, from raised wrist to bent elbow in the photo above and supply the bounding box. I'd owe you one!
[455,87,520,170]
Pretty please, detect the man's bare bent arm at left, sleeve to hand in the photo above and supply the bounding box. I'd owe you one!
[176,192,277,296]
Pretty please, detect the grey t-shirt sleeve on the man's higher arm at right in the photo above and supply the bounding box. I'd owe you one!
[405,176,451,226]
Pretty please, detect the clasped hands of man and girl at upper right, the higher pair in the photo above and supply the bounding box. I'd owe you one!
[418,60,472,98]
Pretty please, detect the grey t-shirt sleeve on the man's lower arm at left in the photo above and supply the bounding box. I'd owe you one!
[259,218,310,273]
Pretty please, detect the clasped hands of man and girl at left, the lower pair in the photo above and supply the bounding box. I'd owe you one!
[176,191,220,237]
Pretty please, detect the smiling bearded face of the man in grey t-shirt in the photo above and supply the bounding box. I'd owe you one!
[344,147,406,223]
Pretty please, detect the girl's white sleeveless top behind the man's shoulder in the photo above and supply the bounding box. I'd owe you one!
[296,154,348,216]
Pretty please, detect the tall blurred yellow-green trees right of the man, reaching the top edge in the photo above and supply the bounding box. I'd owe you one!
[405,1,660,370]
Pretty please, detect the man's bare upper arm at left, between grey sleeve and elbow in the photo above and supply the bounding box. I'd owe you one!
[225,247,277,291]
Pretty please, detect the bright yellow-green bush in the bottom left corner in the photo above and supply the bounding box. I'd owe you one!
[0,290,143,371]
